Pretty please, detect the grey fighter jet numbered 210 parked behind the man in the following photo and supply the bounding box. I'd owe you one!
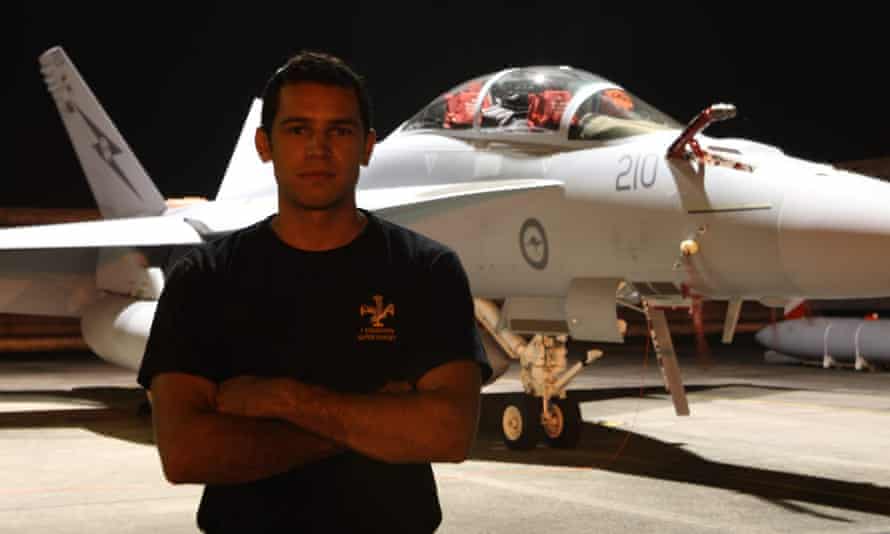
[0,47,890,449]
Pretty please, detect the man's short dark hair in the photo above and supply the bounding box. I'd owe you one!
[260,50,372,136]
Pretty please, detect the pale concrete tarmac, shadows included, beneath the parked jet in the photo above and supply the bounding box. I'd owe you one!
[0,336,890,534]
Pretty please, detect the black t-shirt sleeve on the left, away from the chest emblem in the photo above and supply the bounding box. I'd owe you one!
[137,254,224,389]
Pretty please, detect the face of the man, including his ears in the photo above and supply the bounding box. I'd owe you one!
[256,82,376,210]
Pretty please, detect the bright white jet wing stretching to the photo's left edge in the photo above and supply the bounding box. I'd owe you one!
[0,216,202,250]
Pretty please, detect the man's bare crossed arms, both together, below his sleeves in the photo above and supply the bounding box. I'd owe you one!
[152,361,481,484]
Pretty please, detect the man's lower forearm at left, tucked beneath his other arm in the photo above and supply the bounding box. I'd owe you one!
[156,412,343,484]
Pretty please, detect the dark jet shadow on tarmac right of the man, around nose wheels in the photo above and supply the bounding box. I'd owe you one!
[470,392,890,522]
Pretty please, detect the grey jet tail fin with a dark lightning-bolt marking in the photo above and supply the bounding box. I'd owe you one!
[40,46,166,219]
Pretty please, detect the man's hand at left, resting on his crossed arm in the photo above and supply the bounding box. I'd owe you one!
[216,376,289,417]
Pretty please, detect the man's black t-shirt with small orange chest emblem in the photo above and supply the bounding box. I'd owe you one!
[138,213,491,532]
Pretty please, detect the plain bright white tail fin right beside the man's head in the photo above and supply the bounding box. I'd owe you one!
[216,98,276,200]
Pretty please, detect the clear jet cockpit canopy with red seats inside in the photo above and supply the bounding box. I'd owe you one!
[399,66,683,143]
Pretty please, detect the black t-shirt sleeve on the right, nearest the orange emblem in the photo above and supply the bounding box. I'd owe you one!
[417,250,492,382]
